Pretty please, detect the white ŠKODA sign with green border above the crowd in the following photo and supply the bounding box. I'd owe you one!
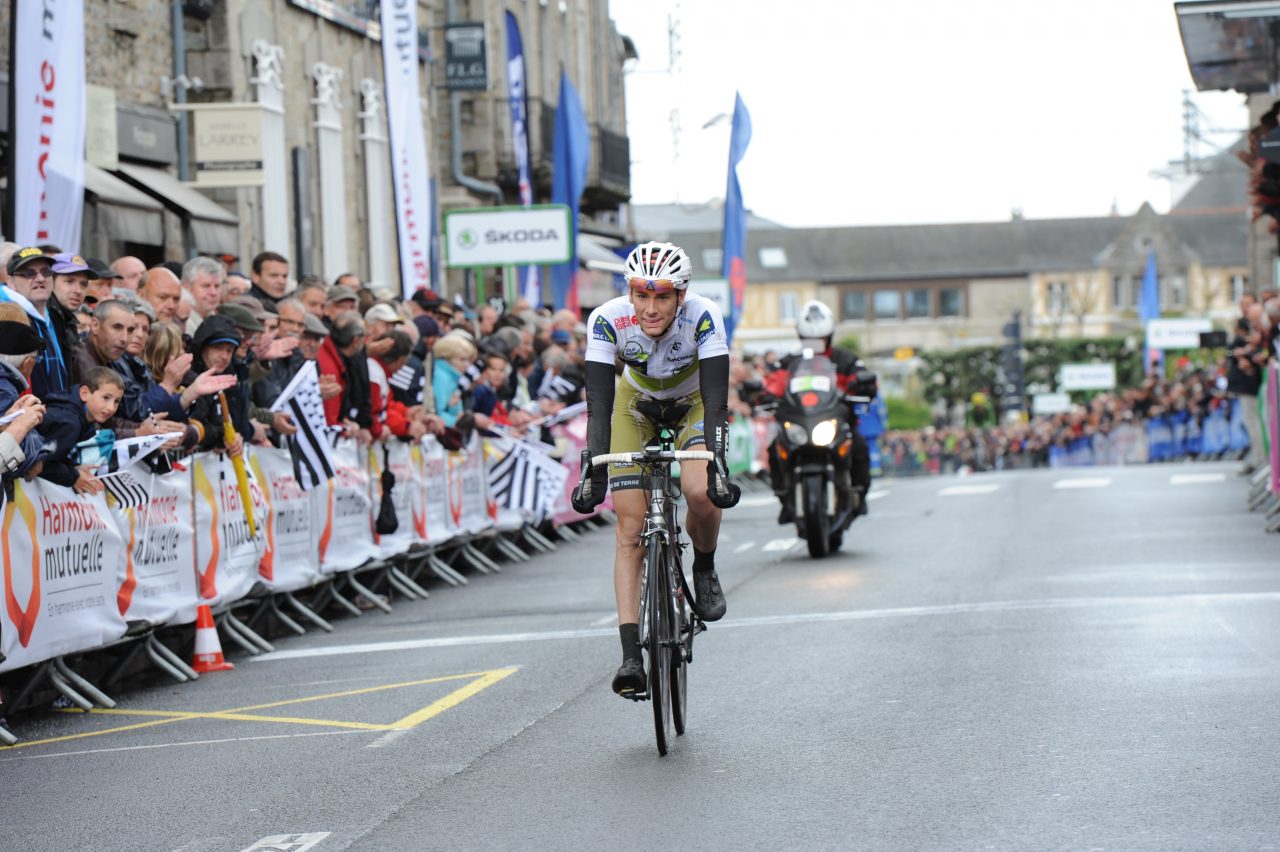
[444,205,571,269]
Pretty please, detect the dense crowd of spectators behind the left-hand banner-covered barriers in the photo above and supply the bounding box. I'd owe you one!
[0,243,586,494]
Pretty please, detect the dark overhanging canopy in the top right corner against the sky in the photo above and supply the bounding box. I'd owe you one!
[1174,0,1280,95]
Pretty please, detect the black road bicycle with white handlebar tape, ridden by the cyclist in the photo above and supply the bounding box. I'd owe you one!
[584,425,716,755]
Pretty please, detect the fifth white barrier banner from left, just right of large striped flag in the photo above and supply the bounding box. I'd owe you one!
[310,440,378,574]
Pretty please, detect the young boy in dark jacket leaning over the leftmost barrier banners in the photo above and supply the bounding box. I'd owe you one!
[40,367,124,494]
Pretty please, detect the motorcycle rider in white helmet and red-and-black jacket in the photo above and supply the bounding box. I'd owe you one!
[764,299,876,523]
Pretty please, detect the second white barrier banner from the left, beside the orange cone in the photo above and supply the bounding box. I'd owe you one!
[111,466,198,624]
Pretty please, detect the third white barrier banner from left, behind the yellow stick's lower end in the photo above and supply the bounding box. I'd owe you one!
[191,453,266,606]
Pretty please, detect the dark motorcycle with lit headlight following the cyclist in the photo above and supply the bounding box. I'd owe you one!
[771,349,876,559]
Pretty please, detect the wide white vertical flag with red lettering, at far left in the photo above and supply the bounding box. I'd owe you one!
[8,0,84,246]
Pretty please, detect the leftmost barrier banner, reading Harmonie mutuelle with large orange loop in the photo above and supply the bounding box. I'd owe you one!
[0,480,124,672]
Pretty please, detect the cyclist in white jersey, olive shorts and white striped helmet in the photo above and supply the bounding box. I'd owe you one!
[572,243,741,697]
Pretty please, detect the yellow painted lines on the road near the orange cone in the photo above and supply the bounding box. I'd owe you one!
[0,667,517,751]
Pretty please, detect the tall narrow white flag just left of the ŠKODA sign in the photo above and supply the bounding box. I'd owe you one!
[381,0,434,298]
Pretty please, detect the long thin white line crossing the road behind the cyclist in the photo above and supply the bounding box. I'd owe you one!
[249,591,1280,665]
